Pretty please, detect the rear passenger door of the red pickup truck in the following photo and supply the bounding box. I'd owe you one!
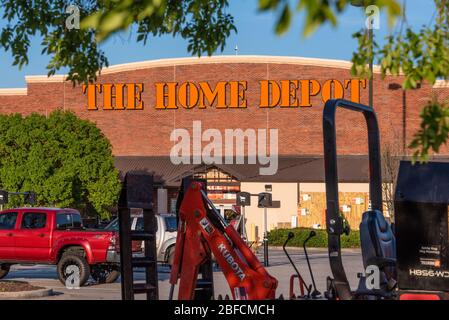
[16,211,51,262]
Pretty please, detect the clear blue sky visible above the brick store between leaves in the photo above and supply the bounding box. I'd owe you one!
[0,0,435,88]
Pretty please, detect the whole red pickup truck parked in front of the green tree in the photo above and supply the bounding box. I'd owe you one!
[0,208,120,286]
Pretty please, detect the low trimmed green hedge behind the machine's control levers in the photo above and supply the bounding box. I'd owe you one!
[268,228,360,248]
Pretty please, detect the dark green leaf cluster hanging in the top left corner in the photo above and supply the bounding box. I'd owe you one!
[0,0,108,82]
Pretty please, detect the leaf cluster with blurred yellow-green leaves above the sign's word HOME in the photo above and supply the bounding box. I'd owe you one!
[82,0,236,55]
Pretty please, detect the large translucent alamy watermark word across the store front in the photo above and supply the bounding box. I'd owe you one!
[170,121,278,175]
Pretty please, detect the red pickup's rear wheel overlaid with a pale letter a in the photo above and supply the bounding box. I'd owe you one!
[57,252,90,287]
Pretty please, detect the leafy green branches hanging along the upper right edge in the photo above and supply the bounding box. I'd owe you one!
[352,0,449,161]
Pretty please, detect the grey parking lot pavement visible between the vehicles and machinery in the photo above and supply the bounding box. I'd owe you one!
[5,248,362,300]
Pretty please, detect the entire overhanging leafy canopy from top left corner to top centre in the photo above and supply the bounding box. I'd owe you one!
[0,0,236,83]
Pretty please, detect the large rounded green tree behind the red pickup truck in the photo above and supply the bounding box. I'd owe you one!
[0,110,120,218]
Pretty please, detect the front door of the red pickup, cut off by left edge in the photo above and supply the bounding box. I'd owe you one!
[0,212,18,260]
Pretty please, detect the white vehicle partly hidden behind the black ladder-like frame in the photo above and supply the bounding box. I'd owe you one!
[105,214,177,265]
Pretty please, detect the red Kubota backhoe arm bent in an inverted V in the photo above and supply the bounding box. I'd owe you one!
[170,182,277,300]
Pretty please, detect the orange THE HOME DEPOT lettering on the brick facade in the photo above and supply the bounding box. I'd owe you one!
[82,79,366,110]
